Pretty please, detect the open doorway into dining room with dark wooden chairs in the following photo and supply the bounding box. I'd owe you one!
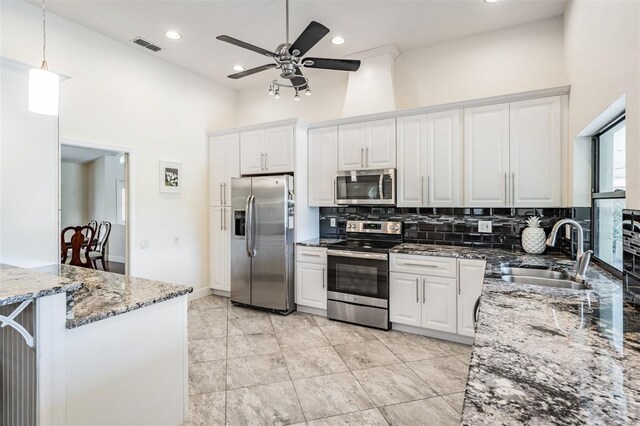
[60,142,130,274]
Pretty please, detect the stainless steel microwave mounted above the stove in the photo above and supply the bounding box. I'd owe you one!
[335,169,396,206]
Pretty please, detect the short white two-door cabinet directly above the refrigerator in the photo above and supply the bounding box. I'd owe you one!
[240,126,293,175]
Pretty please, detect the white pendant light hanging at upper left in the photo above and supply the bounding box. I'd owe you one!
[29,0,60,115]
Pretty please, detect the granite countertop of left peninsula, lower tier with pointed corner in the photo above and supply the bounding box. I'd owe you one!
[34,265,193,328]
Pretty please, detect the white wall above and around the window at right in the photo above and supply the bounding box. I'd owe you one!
[564,0,640,209]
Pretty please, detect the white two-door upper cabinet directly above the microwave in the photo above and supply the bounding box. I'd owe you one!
[338,118,396,170]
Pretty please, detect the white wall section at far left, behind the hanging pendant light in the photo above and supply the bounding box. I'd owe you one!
[0,67,60,267]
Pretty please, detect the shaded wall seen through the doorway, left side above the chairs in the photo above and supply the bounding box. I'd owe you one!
[60,162,89,228]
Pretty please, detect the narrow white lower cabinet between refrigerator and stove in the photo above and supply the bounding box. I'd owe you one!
[296,246,327,310]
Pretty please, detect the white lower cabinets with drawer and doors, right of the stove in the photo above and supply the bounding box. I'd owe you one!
[389,253,485,337]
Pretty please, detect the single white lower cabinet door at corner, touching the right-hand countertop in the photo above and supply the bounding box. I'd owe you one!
[458,259,487,337]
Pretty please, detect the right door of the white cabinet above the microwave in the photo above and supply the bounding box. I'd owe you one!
[365,118,396,169]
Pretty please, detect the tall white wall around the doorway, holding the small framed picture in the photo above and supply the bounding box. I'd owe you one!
[0,1,236,287]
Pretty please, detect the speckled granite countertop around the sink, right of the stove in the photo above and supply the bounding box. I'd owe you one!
[392,244,640,425]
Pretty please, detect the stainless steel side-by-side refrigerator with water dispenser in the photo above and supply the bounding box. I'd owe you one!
[231,175,295,313]
